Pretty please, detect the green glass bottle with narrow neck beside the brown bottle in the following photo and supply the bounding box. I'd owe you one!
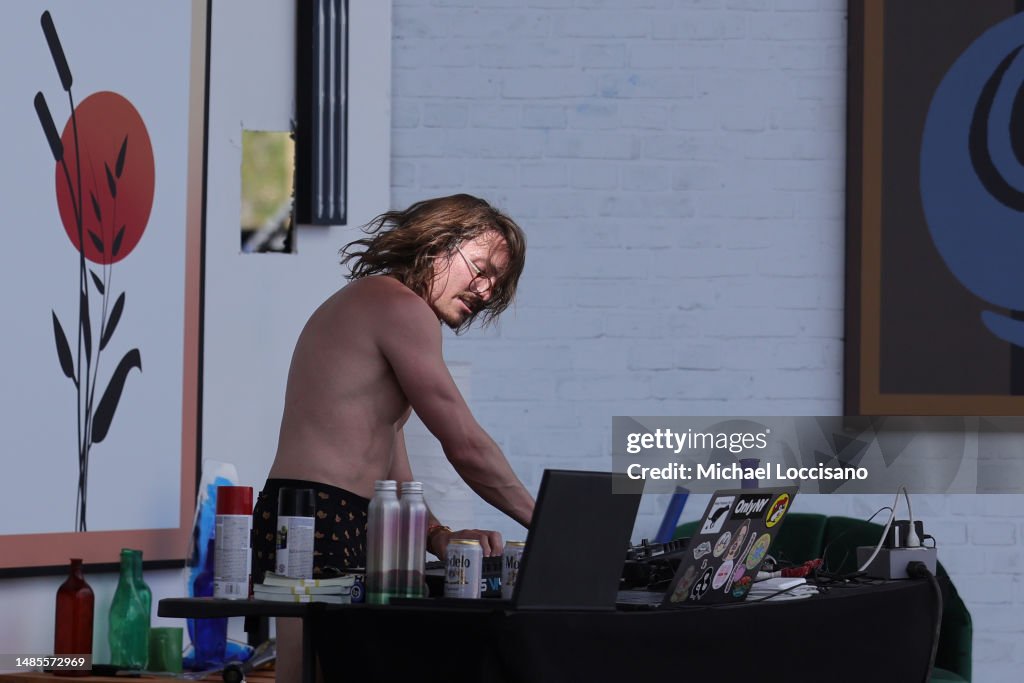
[108,548,152,669]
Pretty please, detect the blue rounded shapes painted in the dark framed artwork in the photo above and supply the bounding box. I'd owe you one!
[908,14,1024,346]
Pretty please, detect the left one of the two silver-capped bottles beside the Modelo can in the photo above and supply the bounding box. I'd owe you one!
[367,479,401,605]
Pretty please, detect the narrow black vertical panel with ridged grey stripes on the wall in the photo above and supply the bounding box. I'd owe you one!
[295,0,348,225]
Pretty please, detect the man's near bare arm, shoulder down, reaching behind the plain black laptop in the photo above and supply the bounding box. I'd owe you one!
[379,295,534,526]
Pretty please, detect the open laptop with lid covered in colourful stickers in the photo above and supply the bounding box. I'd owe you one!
[617,486,798,609]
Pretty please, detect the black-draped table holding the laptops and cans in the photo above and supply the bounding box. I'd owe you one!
[159,581,935,683]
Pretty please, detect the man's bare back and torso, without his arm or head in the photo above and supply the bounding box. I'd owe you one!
[270,275,421,498]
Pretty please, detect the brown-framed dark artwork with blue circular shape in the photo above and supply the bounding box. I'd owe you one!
[844,0,1024,415]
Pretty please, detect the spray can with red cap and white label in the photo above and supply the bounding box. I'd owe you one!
[213,486,253,600]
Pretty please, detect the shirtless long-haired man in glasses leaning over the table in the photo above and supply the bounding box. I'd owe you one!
[253,195,534,681]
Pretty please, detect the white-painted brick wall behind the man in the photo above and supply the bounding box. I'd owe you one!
[392,0,1024,681]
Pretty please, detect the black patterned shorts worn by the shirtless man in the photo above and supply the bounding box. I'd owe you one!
[253,479,370,584]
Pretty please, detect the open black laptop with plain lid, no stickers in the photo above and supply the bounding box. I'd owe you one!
[390,470,642,610]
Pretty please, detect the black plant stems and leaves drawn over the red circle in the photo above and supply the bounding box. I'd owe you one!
[35,11,142,531]
